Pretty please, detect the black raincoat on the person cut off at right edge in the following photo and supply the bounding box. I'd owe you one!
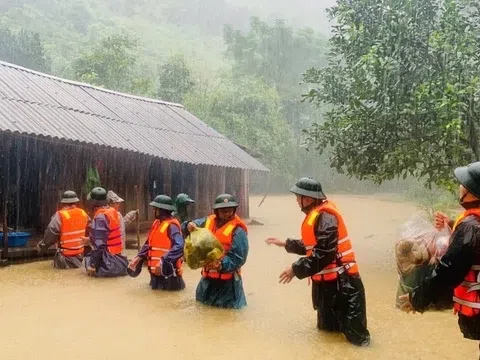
[410,215,480,340]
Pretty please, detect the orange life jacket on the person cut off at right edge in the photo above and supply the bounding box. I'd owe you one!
[453,209,480,317]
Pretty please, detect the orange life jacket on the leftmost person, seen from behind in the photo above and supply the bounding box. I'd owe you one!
[58,207,88,257]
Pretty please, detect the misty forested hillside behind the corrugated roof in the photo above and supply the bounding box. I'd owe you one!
[0,0,333,189]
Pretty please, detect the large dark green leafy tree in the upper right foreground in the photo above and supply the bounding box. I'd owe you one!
[304,0,480,185]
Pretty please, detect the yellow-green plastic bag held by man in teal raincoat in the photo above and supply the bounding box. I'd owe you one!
[184,229,223,270]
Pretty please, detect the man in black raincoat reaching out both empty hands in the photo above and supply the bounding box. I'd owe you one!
[266,177,370,346]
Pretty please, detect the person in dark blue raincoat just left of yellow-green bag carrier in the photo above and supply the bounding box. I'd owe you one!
[128,195,185,291]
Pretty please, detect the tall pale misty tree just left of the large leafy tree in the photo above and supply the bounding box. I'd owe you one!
[224,17,326,135]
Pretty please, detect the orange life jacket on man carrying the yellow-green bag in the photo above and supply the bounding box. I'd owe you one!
[202,215,248,280]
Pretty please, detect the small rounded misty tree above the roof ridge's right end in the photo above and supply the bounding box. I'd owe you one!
[158,55,195,103]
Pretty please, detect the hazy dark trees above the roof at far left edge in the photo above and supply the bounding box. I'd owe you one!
[0,28,51,73]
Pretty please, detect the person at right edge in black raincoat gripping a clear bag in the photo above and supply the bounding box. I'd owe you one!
[399,162,480,356]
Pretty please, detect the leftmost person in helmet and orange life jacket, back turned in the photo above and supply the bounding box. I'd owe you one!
[38,190,89,269]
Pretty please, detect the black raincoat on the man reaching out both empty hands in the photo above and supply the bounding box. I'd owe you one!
[286,207,370,346]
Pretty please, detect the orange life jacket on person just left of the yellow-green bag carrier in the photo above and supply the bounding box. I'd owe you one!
[147,218,183,276]
